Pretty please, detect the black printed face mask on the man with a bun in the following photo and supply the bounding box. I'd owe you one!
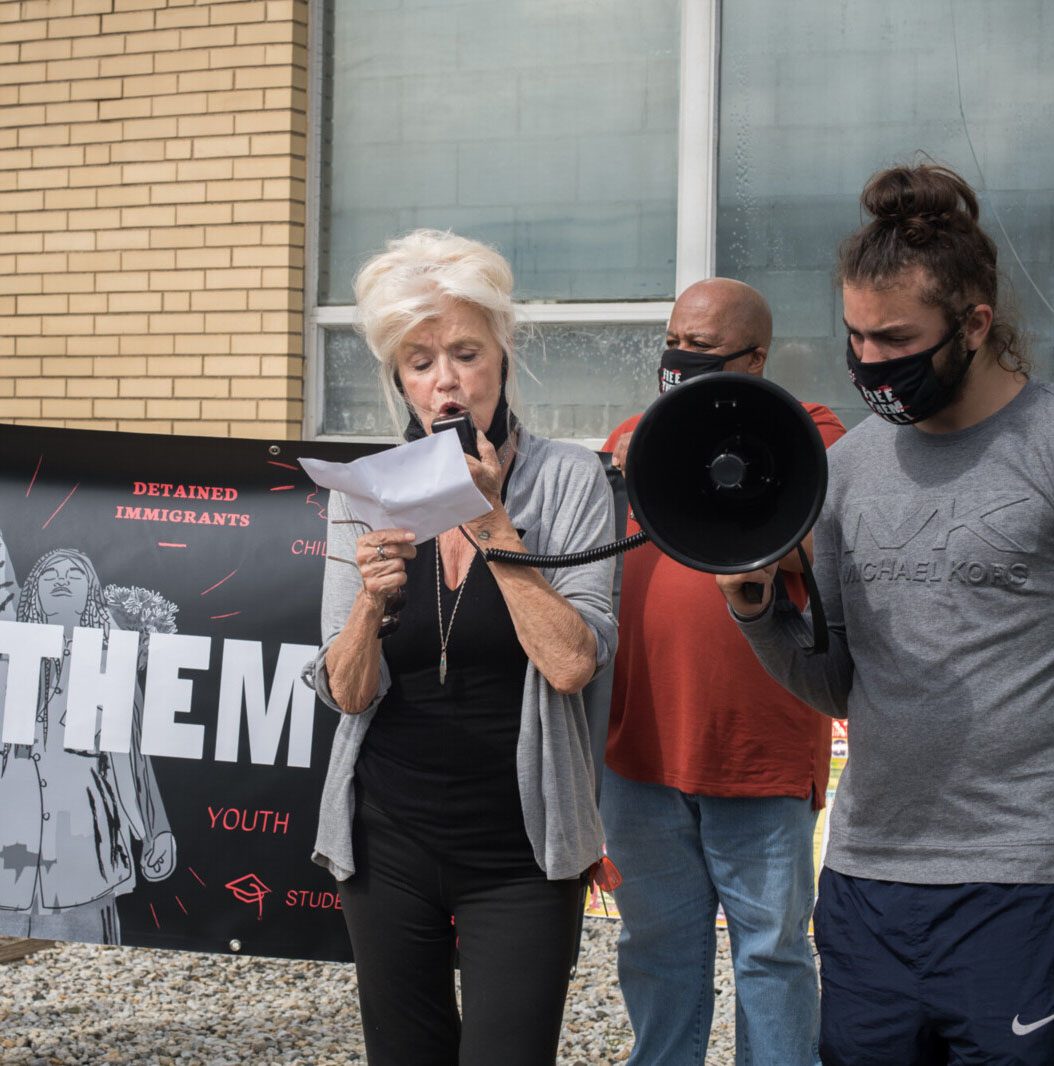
[845,308,977,425]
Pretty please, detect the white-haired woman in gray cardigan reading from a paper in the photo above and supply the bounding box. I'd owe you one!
[304,230,616,1066]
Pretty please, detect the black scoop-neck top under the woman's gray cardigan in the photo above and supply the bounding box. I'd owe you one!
[356,539,538,870]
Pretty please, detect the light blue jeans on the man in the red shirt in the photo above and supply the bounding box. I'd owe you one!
[600,769,820,1066]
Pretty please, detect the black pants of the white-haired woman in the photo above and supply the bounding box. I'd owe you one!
[337,803,583,1066]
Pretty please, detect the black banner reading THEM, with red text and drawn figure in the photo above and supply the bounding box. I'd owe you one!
[0,425,379,960]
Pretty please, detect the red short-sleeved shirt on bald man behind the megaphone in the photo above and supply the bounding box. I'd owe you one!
[604,404,845,809]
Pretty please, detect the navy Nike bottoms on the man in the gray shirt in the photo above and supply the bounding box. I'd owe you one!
[814,868,1054,1066]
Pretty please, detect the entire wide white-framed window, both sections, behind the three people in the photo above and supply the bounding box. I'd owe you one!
[305,0,1054,446]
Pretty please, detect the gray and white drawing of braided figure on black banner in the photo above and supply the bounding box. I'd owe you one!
[0,548,176,943]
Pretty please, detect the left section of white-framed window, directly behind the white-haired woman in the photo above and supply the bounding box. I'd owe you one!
[307,0,714,445]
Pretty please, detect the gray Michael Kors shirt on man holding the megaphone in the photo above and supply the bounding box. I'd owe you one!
[741,382,1054,884]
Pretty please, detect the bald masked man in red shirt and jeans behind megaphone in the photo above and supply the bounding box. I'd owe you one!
[601,278,845,1066]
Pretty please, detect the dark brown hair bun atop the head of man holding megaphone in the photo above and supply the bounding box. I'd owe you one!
[860,164,978,245]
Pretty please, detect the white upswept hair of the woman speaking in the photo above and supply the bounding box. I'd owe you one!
[355,229,518,430]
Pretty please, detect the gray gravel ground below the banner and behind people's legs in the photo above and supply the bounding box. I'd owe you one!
[0,917,734,1066]
